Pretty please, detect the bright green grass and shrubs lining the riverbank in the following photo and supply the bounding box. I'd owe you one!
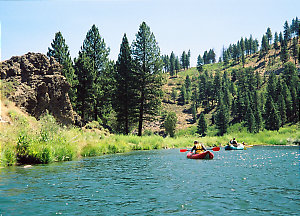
[0,100,300,167]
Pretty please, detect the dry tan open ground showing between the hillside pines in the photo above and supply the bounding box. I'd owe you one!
[144,40,300,134]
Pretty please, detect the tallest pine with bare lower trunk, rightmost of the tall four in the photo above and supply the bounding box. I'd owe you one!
[132,22,162,136]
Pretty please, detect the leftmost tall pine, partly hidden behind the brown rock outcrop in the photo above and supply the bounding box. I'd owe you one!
[47,32,77,107]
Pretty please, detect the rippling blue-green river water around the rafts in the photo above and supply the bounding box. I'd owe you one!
[0,146,300,216]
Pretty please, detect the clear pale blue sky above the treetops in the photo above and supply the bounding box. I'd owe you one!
[0,0,300,66]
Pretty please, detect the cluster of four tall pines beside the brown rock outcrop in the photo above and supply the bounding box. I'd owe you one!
[47,22,163,136]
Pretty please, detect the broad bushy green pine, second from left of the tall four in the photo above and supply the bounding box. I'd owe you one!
[75,25,113,124]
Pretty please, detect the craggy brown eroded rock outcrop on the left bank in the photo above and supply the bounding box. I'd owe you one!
[0,52,77,124]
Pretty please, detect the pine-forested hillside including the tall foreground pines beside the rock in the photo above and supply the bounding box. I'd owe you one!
[47,17,300,136]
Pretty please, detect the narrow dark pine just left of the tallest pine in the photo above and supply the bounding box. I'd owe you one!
[113,34,137,134]
